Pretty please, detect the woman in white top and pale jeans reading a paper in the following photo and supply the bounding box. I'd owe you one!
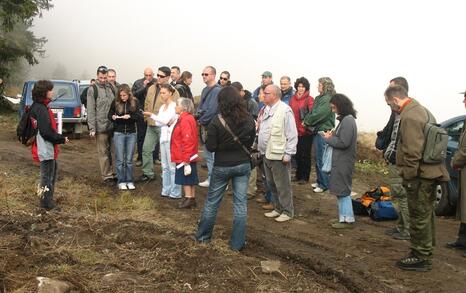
[144,84,181,199]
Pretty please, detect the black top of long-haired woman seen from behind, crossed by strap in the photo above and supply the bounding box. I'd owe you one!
[206,115,256,167]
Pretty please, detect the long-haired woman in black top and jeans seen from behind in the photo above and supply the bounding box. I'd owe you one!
[196,86,256,251]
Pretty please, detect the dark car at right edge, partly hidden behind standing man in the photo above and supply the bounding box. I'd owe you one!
[435,115,466,216]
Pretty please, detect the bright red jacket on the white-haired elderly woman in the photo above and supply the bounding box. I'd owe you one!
[170,112,198,164]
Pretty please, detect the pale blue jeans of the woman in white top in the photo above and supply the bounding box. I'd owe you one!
[160,141,181,198]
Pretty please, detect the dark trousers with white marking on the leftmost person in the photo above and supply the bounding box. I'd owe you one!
[38,160,58,208]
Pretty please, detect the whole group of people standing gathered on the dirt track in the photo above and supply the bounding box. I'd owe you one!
[31,66,466,271]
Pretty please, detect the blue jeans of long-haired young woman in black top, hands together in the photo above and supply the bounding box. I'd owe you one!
[113,132,136,183]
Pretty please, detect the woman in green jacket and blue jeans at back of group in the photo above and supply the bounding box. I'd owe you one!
[303,77,336,193]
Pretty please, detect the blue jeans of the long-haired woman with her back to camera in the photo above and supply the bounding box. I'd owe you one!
[196,162,251,250]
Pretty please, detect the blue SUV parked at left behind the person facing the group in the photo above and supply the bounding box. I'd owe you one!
[19,80,86,138]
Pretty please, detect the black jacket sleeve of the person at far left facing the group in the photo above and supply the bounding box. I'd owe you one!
[29,102,65,144]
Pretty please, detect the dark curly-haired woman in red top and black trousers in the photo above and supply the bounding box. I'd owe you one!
[290,77,314,184]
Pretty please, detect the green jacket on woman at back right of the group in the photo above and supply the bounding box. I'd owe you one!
[303,93,335,133]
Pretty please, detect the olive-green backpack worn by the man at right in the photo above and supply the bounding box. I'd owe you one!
[422,108,448,164]
